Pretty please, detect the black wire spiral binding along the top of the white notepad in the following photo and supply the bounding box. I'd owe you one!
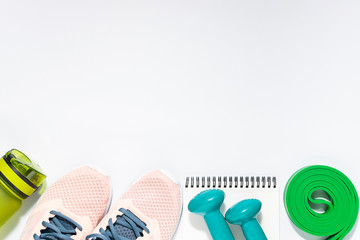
[185,176,277,188]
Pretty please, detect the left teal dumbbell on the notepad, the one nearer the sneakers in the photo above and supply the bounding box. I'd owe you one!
[188,189,234,240]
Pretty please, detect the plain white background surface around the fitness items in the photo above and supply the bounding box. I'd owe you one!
[0,0,360,240]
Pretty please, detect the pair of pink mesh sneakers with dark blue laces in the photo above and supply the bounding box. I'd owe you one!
[20,167,182,240]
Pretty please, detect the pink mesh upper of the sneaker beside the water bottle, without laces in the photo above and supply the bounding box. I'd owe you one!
[20,167,111,240]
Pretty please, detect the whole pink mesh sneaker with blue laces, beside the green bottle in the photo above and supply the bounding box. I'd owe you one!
[20,167,111,240]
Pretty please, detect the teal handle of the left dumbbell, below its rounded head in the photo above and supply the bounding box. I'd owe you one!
[204,211,234,240]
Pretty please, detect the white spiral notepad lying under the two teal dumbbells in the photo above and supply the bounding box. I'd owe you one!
[181,176,280,240]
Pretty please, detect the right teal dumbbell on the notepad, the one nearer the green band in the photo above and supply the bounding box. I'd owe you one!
[225,199,267,240]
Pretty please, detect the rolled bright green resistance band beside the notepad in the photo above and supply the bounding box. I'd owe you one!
[284,165,359,240]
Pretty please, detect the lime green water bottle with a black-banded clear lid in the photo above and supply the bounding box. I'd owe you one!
[0,149,46,227]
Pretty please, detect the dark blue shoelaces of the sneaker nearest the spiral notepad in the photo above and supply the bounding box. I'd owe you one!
[86,208,150,240]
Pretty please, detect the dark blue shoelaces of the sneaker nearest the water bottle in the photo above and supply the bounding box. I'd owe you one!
[33,211,82,240]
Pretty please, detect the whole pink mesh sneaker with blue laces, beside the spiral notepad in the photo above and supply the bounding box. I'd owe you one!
[86,171,182,240]
